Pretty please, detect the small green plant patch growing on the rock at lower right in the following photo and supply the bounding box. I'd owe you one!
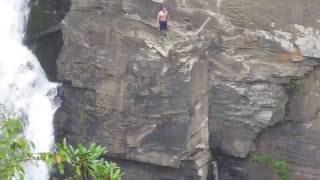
[249,154,291,180]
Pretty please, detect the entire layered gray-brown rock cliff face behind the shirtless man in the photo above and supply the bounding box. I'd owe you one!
[27,0,320,180]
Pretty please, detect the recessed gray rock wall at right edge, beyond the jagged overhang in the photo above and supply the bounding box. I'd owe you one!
[257,71,320,179]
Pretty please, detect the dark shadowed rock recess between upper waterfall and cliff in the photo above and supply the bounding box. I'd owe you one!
[25,0,71,81]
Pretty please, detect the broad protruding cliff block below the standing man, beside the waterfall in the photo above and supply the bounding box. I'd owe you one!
[56,1,210,180]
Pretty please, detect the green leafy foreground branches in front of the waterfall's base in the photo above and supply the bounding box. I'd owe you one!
[0,110,123,180]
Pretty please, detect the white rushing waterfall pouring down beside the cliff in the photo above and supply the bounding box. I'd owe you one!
[0,0,58,180]
